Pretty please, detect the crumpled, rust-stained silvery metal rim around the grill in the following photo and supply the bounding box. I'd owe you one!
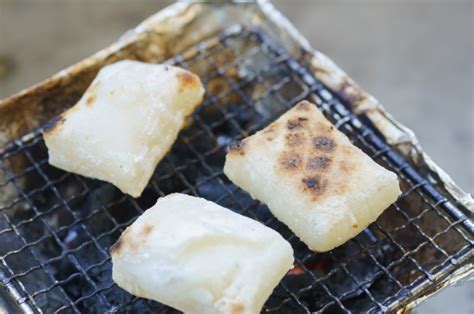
[0,0,474,310]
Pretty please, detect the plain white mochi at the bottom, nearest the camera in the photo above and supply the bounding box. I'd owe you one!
[110,194,293,314]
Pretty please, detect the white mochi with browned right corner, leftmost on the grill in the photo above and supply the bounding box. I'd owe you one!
[43,60,204,197]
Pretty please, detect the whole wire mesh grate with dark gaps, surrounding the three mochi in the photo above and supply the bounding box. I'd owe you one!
[0,26,473,313]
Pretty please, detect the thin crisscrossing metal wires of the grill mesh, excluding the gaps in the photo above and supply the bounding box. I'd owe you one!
[0,25,474,312]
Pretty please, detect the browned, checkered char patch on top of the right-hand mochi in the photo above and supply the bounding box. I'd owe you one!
[266,101,353,201]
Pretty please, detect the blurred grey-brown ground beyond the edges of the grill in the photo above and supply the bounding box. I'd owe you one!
[0,0,474,313]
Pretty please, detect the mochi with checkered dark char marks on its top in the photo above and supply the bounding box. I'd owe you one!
[224,101,401,252]
